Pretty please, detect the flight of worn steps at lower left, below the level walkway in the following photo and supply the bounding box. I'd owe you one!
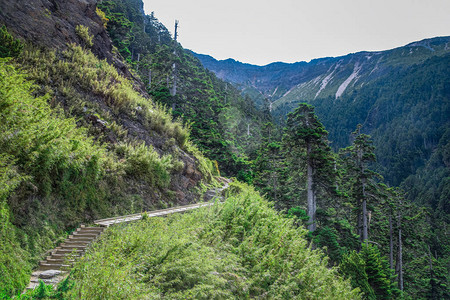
[26,225,104,290]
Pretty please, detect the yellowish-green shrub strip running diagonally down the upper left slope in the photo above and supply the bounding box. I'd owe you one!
[21,44,189,148]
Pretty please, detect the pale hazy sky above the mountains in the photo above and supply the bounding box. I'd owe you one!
[144,0,450,65]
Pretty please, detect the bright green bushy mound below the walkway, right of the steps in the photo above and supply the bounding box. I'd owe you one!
[61,183,358,299]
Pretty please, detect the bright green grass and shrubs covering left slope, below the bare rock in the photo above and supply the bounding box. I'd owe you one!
[0,40,211,296]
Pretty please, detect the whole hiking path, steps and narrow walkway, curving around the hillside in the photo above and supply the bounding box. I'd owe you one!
[26,177,231,290]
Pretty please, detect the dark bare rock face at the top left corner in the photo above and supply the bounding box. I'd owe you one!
[0,0,108,56]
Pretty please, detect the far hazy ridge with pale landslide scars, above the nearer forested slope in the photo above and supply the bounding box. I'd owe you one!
[194,36,450,109]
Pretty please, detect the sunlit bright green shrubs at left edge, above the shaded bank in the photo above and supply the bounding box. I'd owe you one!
[0,57,104,203]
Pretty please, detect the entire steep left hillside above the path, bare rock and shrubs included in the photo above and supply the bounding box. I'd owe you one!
[0,0,217,297]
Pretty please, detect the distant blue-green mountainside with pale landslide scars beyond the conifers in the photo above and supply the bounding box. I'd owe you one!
[196,37,450,185]
